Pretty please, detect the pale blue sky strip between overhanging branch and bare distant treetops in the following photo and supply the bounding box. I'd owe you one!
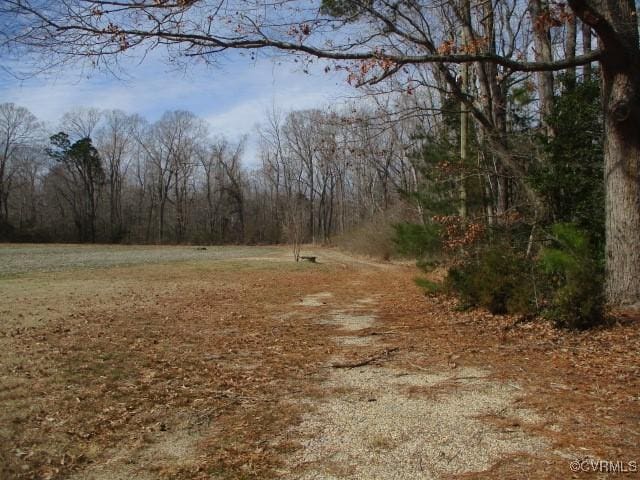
[0,50,355,165]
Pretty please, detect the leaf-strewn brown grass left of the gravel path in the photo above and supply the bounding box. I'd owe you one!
[0,253,356,478]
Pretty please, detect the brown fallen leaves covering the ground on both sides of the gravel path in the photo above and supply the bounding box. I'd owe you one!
[0,253,640,479]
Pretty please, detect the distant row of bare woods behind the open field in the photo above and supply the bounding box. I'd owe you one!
[0,103,418,244]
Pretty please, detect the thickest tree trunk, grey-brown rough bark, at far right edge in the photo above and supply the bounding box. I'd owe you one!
[570,0,640,308]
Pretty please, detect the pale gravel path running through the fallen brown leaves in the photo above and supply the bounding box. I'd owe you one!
[286,286,556,479]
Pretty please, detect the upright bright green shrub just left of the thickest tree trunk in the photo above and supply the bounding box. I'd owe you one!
[540,223,604,329]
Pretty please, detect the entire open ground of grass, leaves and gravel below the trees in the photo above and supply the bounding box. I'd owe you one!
[0,245,640,480]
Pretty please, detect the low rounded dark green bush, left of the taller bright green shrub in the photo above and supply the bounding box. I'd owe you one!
[447,244,535,314]
